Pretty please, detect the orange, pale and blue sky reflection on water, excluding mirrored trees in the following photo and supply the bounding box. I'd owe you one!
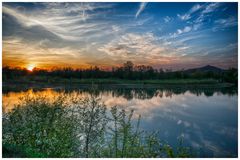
[3,89,237,156]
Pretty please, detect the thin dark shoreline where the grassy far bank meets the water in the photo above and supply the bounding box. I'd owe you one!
[2,82,237,93]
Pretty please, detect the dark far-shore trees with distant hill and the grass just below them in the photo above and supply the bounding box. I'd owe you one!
[2,61,238,84]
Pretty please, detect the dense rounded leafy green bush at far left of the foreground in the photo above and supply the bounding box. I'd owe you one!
[3,96,75,157]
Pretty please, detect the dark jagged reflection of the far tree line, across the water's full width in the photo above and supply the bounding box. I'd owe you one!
[3,85,237,100]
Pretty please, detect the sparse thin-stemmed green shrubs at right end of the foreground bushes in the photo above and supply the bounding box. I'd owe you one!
[102,106,190,158]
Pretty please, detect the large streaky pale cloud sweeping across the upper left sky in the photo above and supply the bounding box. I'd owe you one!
[3,3,114,41]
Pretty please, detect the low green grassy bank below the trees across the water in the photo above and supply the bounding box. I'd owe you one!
[2,77,237,93]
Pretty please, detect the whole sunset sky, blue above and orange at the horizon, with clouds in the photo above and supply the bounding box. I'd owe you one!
[2,2,238,70]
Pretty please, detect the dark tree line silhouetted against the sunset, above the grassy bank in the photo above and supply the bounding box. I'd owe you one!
[2,61,238,84]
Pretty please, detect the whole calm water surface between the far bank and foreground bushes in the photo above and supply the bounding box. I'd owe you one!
[3,87,238,157]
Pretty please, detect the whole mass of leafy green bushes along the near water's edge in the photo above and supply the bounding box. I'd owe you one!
[2,96,193,157]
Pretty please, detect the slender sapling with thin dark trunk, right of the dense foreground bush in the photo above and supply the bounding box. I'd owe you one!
[68,96,107,157]
